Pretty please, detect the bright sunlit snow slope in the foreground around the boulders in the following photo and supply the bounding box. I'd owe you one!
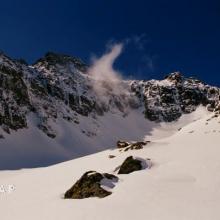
[0,111,220,220]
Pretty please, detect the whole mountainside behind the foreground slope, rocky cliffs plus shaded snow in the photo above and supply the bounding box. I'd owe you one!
[0,53,220,169]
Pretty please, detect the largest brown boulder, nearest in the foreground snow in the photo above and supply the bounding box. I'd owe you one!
[64,171,118,199]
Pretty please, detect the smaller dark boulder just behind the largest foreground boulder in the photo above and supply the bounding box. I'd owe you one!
[118,156,143,174]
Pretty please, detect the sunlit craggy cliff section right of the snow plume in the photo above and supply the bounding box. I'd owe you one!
[131,72,219,122]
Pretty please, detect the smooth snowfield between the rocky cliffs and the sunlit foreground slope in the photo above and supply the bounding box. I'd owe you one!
[0,107,209,170]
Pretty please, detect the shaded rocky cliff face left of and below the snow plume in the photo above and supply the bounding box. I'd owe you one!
[0,53,139,138]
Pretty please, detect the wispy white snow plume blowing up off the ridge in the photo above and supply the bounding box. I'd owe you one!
[88,43,126,99]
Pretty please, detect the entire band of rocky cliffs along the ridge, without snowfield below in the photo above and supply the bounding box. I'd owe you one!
[0,53,219,138]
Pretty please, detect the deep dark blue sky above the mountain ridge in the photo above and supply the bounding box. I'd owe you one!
[0,0,220,85]
